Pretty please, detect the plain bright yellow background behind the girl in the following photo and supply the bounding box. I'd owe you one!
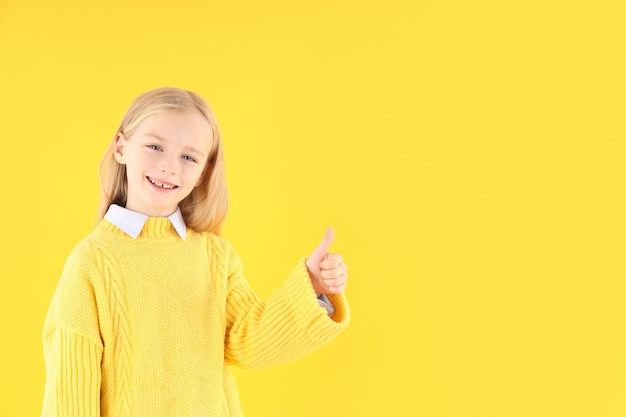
[0,0,626,417]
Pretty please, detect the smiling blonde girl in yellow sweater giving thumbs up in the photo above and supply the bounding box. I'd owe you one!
[43,88,349,417]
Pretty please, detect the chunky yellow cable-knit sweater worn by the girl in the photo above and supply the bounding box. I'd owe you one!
[42,218,349,417]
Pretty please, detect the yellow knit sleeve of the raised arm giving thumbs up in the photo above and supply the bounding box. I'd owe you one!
[225,245,350,368]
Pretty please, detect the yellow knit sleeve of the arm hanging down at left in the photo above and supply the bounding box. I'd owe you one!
[42,240,103,417]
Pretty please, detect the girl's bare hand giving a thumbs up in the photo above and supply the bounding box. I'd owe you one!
[306,227,348,295]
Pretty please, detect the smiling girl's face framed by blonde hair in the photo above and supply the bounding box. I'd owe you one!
[115,111,213,217]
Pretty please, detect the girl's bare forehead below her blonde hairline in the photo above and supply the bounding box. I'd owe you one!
[133,111,213,152]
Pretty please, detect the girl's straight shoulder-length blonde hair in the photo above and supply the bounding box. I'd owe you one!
[98,87,228,234]
